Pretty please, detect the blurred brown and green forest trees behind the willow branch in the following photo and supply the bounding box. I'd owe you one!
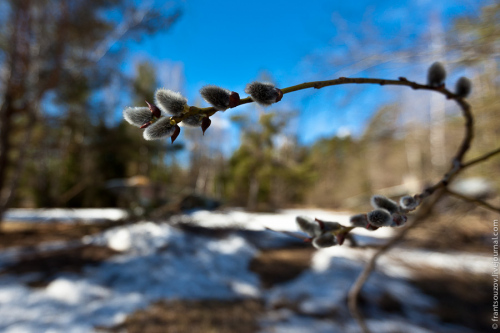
[0,0,500,214]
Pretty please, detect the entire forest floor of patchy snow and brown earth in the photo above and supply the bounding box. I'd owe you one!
[0,209,492,333]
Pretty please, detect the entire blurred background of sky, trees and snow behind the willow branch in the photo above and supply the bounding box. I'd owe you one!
[0,0,500,332]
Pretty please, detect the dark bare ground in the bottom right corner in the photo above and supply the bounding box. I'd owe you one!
[410,268,493,332]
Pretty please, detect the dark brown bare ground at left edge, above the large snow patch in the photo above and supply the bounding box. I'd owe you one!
[0,245,117,287]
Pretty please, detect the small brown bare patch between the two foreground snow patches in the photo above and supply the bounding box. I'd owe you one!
[249,244,316,288]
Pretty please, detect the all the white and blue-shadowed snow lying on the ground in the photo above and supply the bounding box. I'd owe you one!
[0,210,491,333]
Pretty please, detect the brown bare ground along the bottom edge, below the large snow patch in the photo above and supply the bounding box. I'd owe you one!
[96,299,264,333]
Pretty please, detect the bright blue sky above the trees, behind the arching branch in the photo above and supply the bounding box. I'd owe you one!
[119,0,485,148]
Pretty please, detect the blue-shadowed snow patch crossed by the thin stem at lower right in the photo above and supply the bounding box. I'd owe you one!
[262,249,469,333]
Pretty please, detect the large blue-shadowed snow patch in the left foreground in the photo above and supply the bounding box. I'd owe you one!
[0,222,259,333]
